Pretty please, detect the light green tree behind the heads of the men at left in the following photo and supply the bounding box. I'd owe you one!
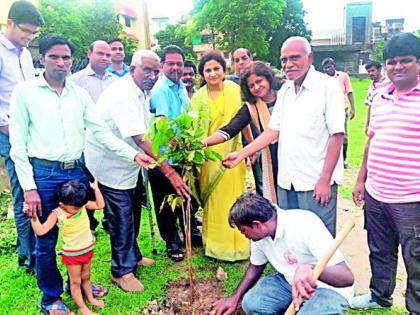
[39,0,135,58]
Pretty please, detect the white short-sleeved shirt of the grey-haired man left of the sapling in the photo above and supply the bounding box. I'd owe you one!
[85,76,152,189]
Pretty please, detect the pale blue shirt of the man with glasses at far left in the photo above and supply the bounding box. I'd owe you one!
[0,34,35,126]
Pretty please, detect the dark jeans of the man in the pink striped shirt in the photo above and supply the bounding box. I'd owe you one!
[364,192,420,315]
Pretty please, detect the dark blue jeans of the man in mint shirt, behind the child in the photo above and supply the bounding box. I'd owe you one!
[32,161,89,305]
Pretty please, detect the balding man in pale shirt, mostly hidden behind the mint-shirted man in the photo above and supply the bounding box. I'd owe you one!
[70,40,118,103]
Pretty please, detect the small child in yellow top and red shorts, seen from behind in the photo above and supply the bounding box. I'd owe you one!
[31,180,105,315]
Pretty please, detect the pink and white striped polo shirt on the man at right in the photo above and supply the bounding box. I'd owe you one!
[366,81,420,203]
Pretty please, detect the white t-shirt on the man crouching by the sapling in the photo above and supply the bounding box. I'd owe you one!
[250,206,354,301]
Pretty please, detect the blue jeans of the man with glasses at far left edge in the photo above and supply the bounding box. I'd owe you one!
[0,132,35,268]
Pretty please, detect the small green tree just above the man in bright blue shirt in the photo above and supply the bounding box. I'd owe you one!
[155,23,197,60]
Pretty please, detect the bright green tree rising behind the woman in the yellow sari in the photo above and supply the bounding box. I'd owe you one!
[193,0,286,56]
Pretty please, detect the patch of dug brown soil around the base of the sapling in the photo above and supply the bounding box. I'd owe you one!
[143,279,244,315]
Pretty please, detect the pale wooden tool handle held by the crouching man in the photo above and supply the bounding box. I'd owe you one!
[284,220,355,315]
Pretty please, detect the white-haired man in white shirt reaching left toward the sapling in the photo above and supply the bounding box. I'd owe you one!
[223,37,345,236]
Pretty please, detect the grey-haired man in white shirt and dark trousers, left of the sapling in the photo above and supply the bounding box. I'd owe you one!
[85,50,190,292]
